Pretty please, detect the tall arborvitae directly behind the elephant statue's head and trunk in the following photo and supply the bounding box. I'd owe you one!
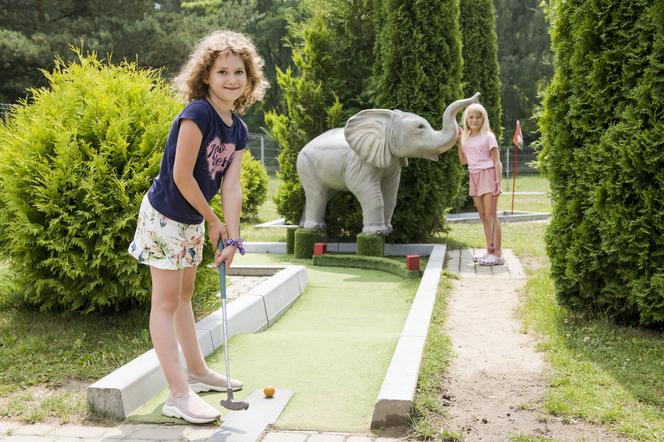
[376,0,463,242]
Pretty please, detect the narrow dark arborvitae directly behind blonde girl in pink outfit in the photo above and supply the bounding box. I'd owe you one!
[455,0,503,208]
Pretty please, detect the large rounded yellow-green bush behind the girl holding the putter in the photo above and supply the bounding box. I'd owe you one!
[0,55,267,313]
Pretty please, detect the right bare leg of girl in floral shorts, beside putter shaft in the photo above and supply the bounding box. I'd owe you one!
[175,267,208,376]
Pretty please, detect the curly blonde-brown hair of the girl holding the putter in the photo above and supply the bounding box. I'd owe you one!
[173,31,269,114]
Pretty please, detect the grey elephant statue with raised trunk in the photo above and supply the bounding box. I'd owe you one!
[297,93,480,236]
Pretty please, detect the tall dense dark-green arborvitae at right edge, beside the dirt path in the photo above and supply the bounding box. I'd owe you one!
[540,0,664,327]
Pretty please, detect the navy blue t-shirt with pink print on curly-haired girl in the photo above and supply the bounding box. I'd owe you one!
[148,98,248,224]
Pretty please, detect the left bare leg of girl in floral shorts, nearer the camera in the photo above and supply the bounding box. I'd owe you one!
[150,266,189,396]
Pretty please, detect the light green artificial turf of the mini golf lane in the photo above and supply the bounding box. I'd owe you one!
[129,254,419,431]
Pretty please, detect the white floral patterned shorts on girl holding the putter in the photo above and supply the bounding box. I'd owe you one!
[129,195,205,270]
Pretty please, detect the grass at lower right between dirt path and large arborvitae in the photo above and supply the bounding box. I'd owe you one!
[519,268,664,441]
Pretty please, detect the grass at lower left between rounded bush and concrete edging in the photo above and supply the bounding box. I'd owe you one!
[0,267,218,423]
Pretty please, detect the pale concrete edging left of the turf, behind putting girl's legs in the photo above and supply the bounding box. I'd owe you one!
[87,264,308,419]
